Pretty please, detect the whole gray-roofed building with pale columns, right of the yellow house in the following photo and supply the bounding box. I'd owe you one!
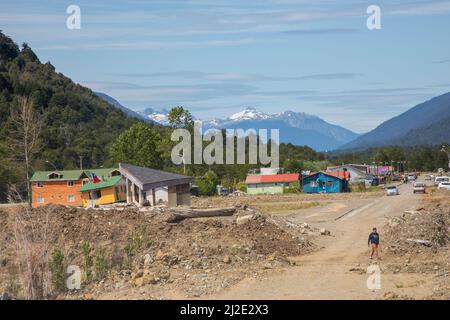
[119,163,193,206]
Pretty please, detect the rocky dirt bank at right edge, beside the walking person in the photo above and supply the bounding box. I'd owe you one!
[384,192,450,299]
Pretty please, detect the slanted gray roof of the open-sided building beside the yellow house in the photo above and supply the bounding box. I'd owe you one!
[119,163,194,190]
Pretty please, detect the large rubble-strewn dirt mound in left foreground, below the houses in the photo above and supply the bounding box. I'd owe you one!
[0,206,313,298]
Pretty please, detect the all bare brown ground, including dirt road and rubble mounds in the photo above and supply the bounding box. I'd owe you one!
[0,179,450,299]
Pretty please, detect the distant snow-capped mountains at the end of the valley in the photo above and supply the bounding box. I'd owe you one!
[136,108,358,151]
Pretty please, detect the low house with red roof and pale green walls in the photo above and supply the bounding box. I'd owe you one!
[245,173,300,194]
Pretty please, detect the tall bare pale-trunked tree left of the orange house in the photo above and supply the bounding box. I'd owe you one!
[7,96,43,205]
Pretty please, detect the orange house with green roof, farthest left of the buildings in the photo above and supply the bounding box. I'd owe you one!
[31,169,120,207]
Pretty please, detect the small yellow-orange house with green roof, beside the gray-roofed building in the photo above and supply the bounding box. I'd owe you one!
[78,175,126,208]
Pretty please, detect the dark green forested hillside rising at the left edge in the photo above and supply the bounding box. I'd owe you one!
[0,32,137,199]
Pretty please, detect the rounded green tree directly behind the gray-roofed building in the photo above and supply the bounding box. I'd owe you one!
[111,122,163,168]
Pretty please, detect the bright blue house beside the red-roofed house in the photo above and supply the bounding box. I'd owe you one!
[302,172,348,193]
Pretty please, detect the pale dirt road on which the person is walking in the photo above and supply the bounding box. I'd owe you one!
[207,185,432,299]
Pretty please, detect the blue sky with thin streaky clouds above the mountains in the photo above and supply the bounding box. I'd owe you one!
[0,0,450,132]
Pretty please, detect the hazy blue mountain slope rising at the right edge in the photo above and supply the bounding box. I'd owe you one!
[340,92,450,150]
